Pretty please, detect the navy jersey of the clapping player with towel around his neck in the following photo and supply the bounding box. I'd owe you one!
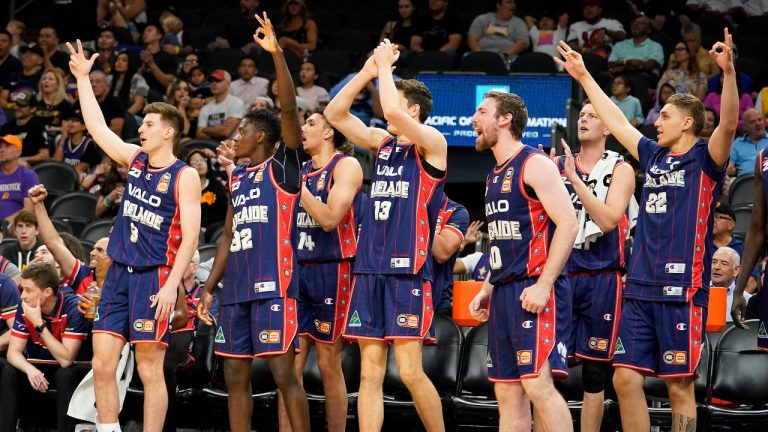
[557,153,629,274]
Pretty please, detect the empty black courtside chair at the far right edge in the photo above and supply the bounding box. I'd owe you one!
[707,320,768,430]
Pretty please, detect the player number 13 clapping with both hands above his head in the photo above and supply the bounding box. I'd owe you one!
[325,40,447,431]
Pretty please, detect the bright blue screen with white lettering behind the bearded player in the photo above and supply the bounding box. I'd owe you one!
[416,73,573,147]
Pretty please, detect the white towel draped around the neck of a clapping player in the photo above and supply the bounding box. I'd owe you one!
[573,150,640,250]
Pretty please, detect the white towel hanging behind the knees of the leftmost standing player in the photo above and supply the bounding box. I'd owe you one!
[67,344,134,423]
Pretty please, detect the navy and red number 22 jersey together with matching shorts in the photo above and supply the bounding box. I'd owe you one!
[614,137,725,377]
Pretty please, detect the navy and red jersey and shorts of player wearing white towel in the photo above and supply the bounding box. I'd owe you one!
[557,153,629,361]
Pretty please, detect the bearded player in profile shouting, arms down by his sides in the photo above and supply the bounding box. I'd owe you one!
[470,92,578,431]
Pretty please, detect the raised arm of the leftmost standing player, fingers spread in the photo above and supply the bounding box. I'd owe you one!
[67,39,139,165]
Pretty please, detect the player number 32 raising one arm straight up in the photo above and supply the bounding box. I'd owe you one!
[198,14,309,432]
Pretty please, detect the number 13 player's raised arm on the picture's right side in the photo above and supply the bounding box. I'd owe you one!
[373,39,448,170]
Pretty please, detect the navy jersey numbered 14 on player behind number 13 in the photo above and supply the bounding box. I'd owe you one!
[295,153,360,262]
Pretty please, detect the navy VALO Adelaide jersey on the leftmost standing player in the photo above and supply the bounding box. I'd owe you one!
[107,150,191,267]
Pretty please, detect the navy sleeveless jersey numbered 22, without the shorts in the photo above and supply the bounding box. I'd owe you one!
[624,137,725,306]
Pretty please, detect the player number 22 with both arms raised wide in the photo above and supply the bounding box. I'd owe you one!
[555,29,739,431]
